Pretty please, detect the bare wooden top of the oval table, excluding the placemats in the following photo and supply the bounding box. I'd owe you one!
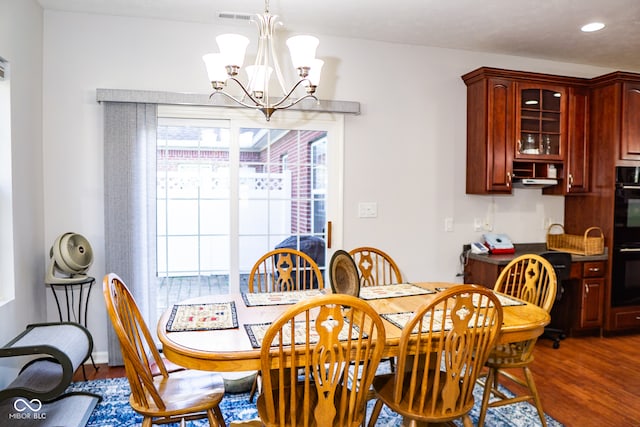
[157,282,550,372]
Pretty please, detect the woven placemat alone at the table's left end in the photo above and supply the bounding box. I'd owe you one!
[167,301,238,332]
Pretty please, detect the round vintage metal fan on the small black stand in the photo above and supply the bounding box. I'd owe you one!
[45,233,93,284]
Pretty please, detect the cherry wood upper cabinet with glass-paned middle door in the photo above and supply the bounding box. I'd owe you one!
[462,67,588,194]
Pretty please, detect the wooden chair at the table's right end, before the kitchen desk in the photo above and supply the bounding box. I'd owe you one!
[478,254,557,426]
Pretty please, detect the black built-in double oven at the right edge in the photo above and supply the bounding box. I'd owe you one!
[611,166,640,307]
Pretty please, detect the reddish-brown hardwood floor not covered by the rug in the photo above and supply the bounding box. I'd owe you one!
[75,334,640,427]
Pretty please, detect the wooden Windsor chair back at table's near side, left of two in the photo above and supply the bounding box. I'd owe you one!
[257,294,385,427]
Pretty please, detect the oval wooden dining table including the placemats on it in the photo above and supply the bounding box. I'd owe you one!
[157,282,550,372]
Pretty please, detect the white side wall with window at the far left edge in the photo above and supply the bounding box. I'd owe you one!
[0,0,46,385]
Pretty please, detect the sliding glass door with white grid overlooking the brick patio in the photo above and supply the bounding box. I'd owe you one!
[155,107,342,320]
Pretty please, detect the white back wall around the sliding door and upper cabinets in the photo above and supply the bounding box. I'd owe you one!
[38,11,610,362]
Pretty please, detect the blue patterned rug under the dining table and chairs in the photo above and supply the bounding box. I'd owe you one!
[68,378,562,427]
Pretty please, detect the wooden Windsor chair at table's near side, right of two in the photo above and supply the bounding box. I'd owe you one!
[369,285,502,427]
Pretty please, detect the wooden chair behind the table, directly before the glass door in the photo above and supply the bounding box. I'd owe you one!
[248,248,324,293]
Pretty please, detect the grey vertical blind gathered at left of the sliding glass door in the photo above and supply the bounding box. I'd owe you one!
[104,102,158,366]
